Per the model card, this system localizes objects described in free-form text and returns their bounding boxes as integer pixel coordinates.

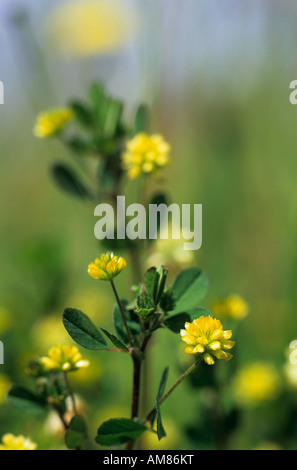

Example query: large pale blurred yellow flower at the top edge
[46,0,139,58]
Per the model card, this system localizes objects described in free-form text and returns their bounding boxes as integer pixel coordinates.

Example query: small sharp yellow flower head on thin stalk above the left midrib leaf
[88,253,127,281]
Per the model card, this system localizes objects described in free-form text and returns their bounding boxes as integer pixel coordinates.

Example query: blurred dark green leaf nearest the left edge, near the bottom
[7,385,47,412]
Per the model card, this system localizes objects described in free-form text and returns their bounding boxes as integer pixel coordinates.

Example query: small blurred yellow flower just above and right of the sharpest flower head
[212,294,249,320]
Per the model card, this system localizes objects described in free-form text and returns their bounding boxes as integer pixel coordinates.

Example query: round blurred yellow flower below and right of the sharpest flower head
[233,362,280,406]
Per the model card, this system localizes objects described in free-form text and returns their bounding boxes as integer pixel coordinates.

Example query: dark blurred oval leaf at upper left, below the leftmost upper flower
[52,164,90,199]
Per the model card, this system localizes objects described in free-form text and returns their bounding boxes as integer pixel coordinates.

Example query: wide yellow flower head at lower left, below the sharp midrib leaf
[40,344,89,372]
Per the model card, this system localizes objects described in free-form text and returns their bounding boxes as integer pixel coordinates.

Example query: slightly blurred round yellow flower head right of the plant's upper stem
[122,132,170,180]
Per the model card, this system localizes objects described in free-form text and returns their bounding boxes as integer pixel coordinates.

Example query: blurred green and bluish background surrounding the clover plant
[0,0,297,449]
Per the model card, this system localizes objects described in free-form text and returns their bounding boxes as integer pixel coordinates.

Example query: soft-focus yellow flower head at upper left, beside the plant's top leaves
[34,108,74,139]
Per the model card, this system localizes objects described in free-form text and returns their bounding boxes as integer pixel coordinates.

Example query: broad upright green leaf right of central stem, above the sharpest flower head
[171,268,208,314]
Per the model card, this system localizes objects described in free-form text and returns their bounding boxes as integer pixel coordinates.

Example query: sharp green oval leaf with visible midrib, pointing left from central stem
[63,308,107,351]
